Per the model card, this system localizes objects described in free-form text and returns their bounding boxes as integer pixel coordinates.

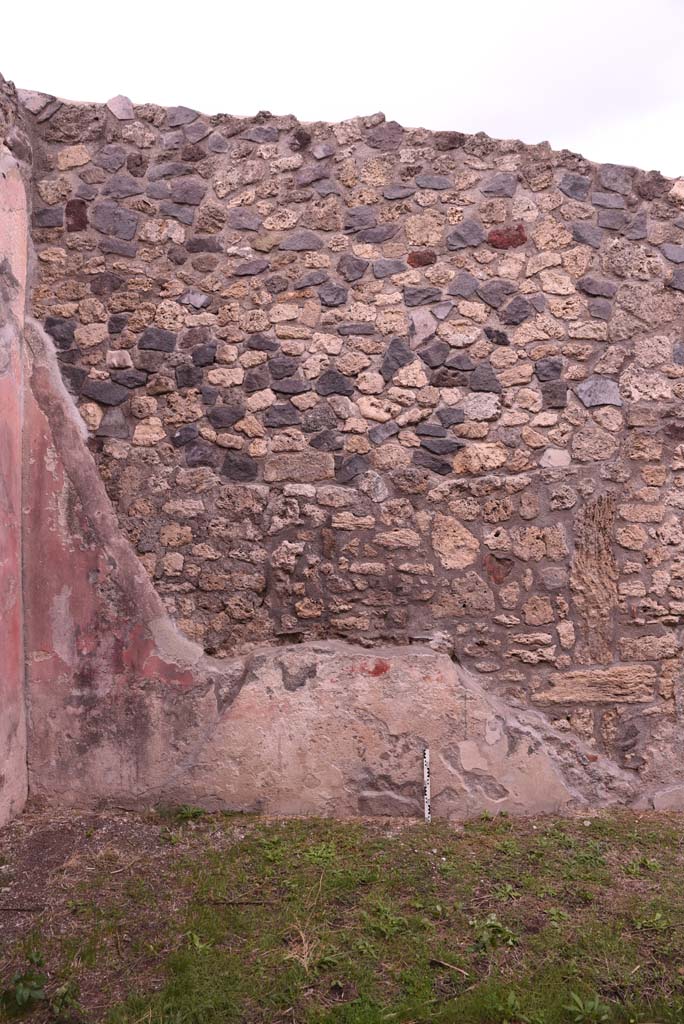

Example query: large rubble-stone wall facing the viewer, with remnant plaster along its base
[3,75,684,815]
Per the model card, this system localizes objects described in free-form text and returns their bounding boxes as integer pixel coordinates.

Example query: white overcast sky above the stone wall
[0,0,684,176]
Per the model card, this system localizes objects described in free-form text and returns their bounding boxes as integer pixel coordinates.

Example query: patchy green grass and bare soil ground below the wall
[0,807,684,1024]
